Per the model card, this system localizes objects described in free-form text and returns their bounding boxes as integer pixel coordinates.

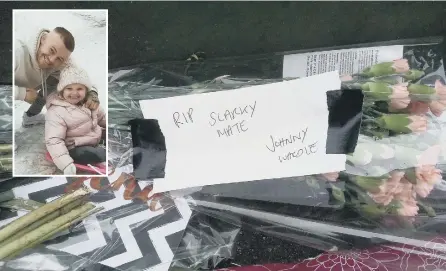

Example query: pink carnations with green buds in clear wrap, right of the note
[324,59,446,225]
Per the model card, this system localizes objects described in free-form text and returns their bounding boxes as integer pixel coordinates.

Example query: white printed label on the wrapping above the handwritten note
[283,45,404,78]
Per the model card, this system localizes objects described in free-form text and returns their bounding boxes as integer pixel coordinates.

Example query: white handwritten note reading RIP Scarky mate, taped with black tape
[140,72,345,192]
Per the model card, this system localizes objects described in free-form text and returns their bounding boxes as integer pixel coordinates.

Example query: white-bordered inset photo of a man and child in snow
[13,10,108,176]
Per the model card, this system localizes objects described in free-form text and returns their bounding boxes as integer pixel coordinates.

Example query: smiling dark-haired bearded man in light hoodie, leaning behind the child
[14,27,99,127]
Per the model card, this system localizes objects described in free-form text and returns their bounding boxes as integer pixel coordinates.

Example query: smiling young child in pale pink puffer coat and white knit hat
[45,65,106,175]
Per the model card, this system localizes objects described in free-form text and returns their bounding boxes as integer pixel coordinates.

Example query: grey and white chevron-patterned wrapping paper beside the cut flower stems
[0,168,191,271]
